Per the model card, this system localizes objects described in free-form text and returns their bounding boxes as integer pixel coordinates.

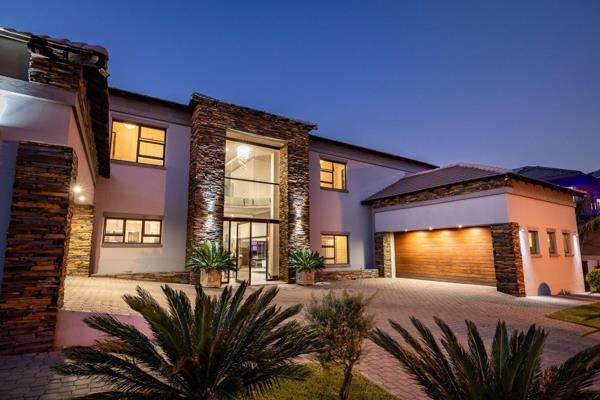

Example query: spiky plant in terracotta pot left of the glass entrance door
[187,240,235,288]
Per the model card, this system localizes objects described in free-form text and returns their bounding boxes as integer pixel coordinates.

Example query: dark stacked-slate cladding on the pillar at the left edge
[0,142,77,355]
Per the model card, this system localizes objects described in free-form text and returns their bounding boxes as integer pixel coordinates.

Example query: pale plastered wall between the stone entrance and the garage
[309,139,432,269]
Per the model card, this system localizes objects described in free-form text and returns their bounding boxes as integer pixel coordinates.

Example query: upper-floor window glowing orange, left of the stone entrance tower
[110,121,166,166]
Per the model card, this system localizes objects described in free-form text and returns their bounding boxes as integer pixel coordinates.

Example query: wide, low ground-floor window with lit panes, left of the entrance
[102,217,162,244]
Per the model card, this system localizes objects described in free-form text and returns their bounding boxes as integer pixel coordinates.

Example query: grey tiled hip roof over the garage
[363,163,579,203]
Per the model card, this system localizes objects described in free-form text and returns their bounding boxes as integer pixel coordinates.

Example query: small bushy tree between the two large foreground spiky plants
[307,291,375,400]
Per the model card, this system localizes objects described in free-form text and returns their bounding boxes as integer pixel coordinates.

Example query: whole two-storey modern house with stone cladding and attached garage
[0,29,583,353]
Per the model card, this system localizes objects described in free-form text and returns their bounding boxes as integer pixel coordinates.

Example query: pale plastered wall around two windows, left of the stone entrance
[95,97,190,274]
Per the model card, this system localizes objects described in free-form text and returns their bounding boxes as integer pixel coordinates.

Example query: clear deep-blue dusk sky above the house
[0,0,600,172]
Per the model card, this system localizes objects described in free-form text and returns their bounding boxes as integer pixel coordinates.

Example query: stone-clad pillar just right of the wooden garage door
[490,222,525,296]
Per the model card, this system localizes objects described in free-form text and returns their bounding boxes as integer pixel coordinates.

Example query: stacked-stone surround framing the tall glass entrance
[187,94,315,281]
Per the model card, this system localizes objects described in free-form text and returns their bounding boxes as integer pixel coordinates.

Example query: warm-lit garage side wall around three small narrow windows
[507,185,584,296]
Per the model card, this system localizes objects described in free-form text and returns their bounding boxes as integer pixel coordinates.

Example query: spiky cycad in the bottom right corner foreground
[371,317,600,400]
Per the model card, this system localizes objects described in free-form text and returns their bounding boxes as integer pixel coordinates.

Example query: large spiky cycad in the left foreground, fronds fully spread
[55,283,320,400]
